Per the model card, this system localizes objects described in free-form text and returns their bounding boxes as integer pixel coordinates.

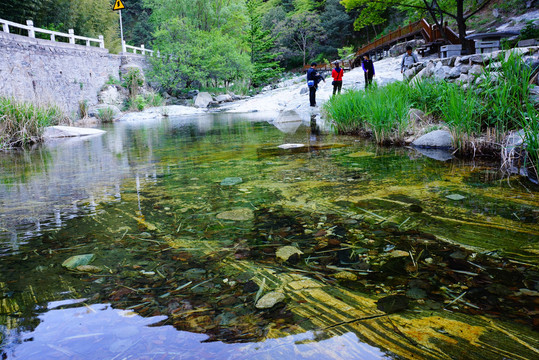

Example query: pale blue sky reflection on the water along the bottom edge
[2,300,384,360]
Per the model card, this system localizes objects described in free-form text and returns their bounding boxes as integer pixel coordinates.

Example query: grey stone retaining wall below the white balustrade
[0,32,152,118]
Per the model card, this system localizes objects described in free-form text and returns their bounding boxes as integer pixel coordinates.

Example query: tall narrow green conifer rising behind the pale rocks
[246,0,282,87]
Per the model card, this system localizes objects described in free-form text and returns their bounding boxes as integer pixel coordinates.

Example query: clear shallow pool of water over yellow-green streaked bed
[0,114,539,359]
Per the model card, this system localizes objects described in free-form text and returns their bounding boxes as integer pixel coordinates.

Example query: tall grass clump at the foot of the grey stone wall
[0,97,68,149]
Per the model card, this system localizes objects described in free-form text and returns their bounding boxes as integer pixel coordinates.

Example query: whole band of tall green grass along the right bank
[324,53,537,160]
